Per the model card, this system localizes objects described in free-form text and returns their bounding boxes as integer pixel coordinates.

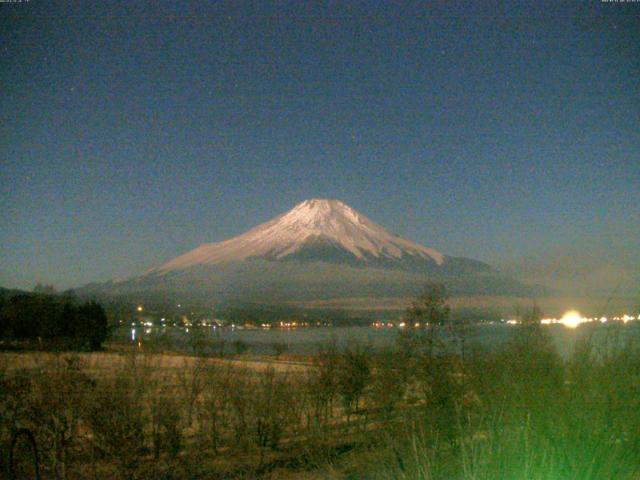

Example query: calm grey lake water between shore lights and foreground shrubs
[114,321,640,355]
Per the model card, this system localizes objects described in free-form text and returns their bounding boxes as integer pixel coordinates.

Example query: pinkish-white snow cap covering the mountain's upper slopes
[154,199,446,274]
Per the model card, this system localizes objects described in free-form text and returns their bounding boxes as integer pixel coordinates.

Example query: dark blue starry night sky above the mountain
[0,0,640,288]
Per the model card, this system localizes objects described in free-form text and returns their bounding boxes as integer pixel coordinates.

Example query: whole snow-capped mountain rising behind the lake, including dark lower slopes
[87,199,527,300]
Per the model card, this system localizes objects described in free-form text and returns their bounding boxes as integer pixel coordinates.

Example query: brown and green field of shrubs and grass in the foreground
[0,286,640,480]
